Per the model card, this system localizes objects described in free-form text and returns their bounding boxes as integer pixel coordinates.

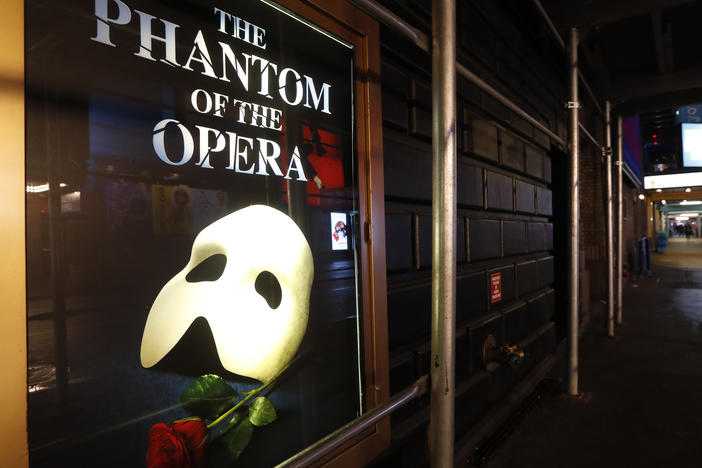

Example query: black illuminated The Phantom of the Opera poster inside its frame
[26,0,363,468]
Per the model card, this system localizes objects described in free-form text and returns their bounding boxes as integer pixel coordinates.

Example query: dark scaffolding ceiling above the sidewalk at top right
[542,0,702,114]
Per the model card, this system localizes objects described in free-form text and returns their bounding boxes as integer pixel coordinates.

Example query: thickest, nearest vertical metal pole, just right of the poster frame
[429,0,456,468]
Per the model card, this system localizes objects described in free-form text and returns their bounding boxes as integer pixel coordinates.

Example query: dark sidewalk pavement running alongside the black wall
[484,239,702,468]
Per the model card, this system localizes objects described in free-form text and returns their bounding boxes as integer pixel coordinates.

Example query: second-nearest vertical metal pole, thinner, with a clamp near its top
[568,28,580,395]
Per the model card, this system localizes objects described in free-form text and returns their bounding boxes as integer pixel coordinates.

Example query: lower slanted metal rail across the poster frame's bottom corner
[276,376,427,468]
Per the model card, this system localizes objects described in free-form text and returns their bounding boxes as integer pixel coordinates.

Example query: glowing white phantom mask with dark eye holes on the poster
[141,205,314,383]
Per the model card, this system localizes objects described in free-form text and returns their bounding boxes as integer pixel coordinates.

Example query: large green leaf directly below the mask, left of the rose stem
[180,374,237,419]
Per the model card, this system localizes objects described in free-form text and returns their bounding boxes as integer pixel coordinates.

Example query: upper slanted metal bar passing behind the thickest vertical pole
[351,0,566,146]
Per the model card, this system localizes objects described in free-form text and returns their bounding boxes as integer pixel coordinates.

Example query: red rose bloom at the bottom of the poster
[146,419,207,468]
